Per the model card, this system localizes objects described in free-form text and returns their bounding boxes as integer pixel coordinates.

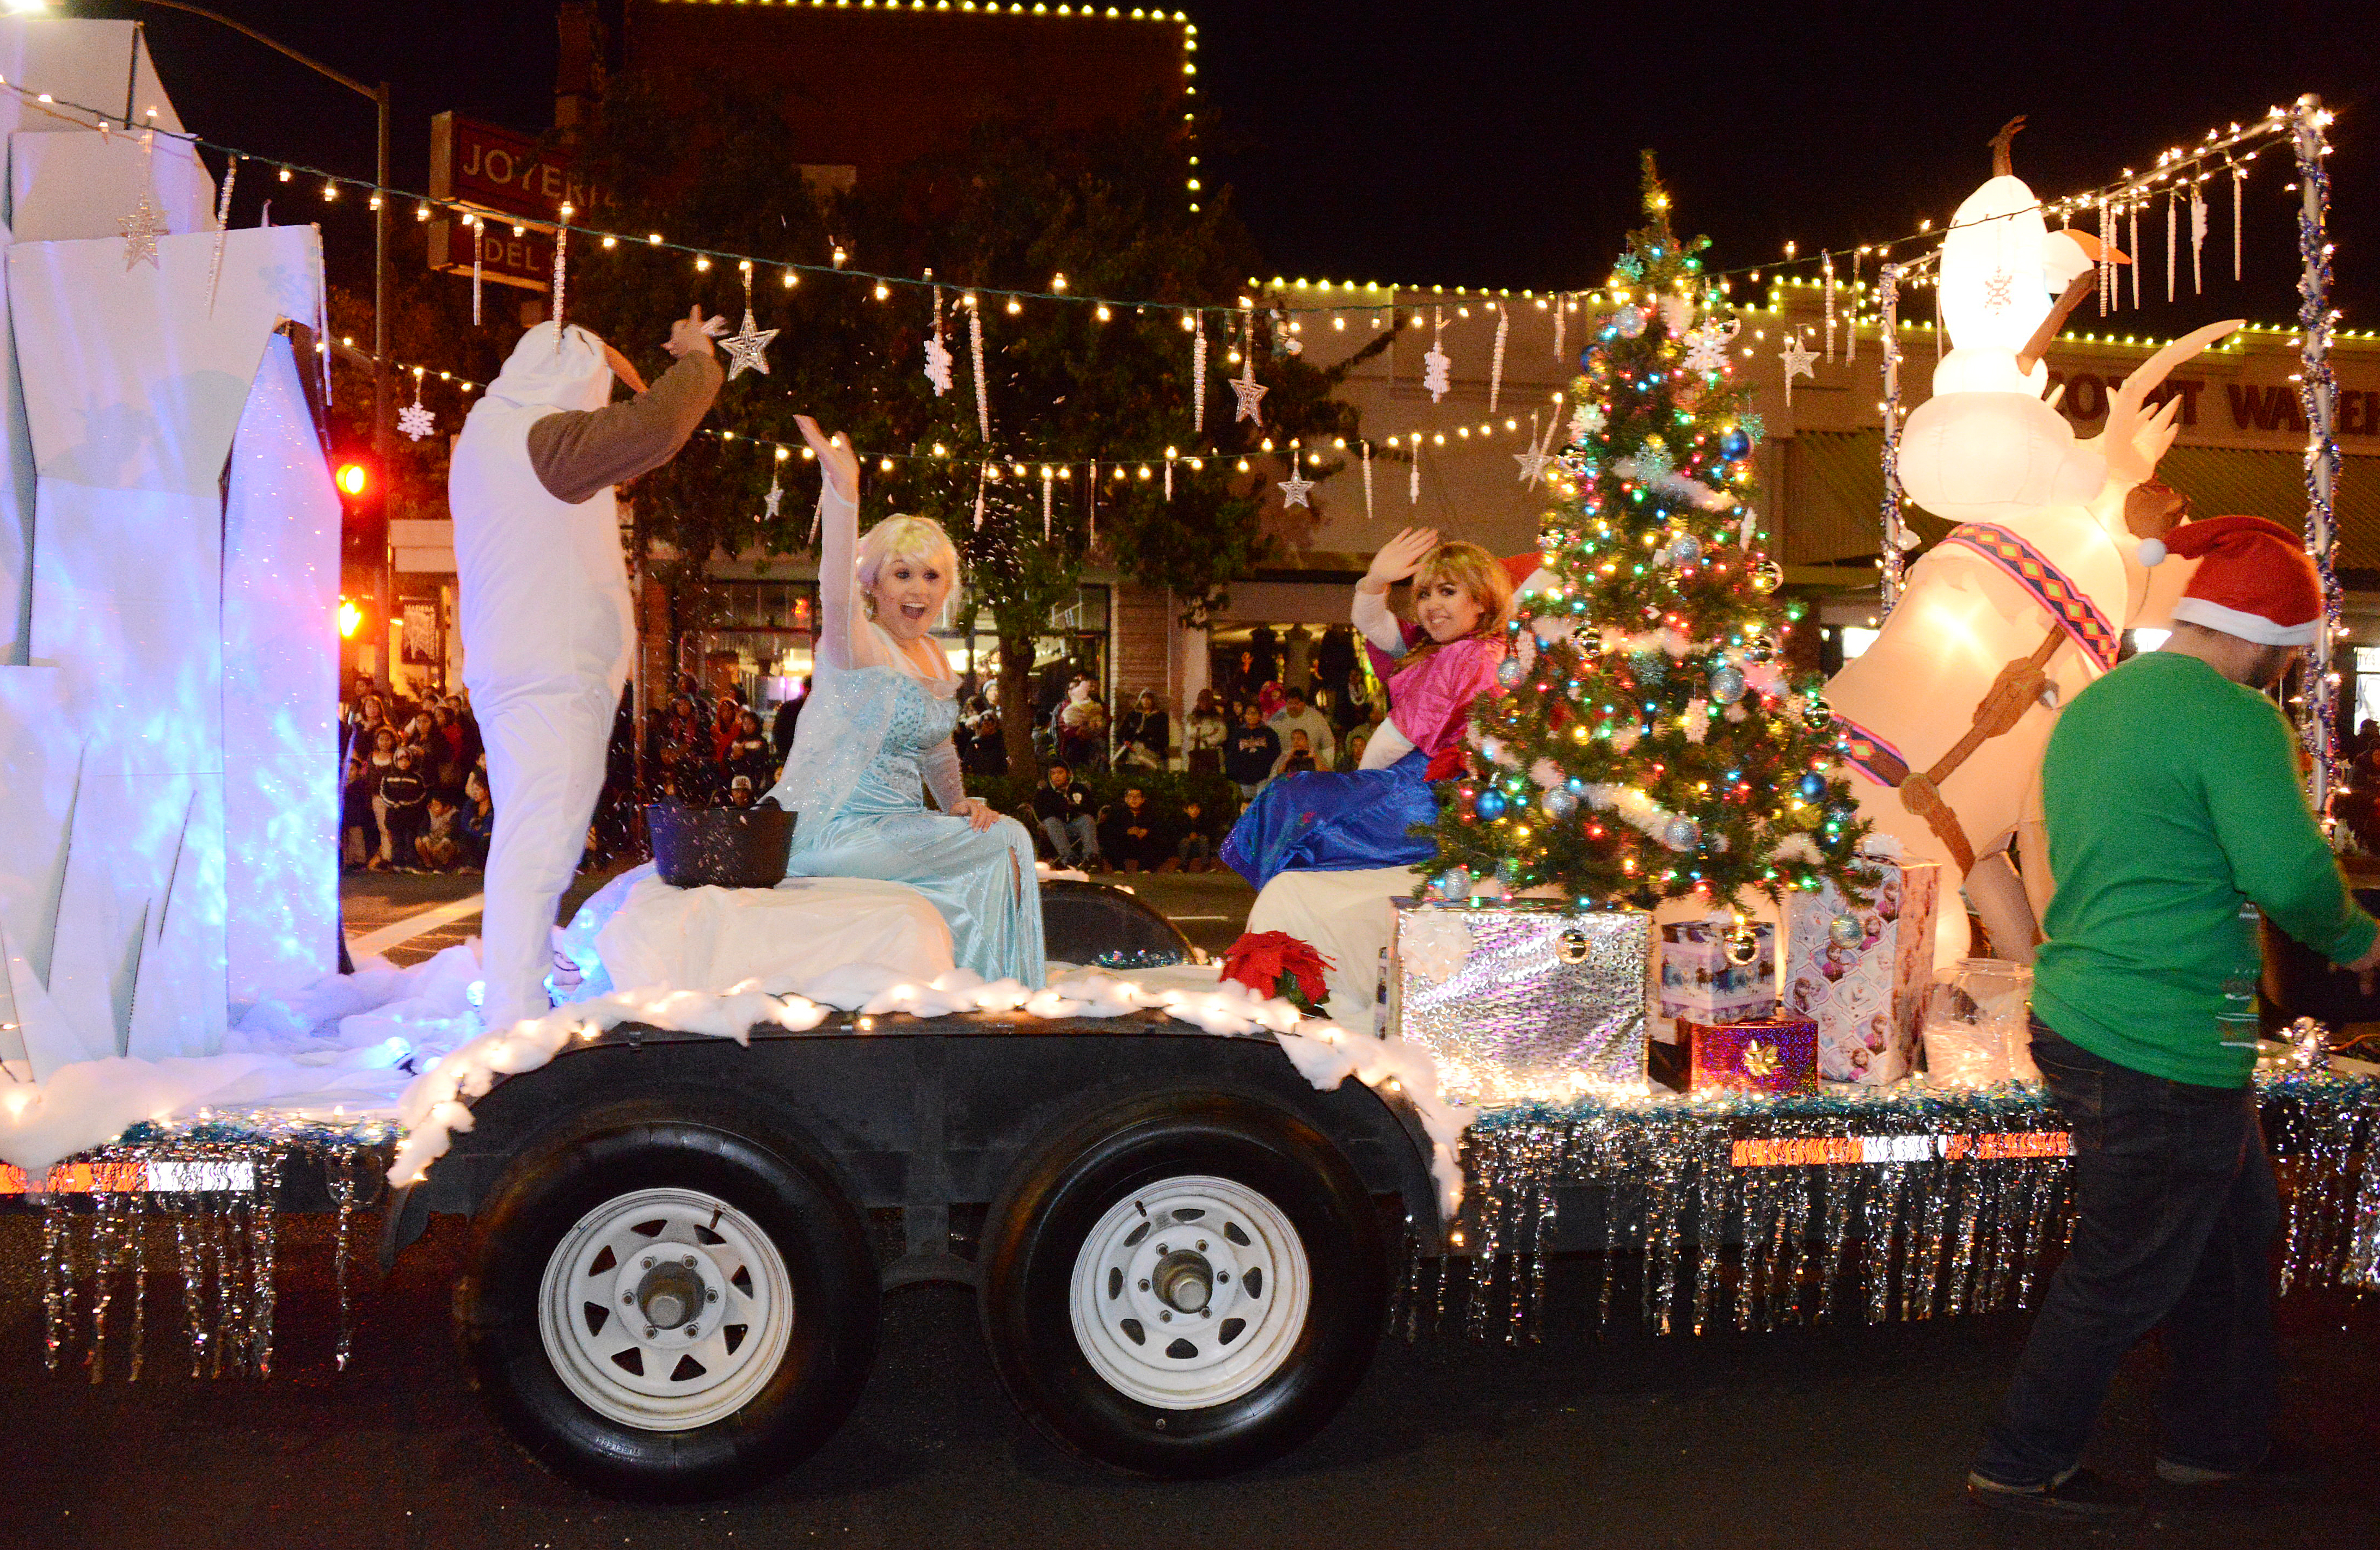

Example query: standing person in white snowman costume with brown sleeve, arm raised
[447,307,721,1029]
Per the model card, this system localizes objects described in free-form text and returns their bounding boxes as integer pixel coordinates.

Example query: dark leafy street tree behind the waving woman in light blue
[571,76,1393,769]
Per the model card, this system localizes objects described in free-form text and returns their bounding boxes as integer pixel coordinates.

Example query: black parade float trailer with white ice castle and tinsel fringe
[0,21,2380,1498]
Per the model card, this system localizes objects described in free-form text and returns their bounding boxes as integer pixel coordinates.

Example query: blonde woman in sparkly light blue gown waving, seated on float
[769,414,1042,988]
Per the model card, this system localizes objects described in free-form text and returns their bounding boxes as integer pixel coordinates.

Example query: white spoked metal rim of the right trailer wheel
[1069,1174,1314,1410]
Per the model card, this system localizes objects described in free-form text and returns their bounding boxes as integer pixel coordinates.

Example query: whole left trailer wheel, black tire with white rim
[455,1100,881,1503]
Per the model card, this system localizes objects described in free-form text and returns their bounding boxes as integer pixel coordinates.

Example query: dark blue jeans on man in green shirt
[1976,1022,2280,1486]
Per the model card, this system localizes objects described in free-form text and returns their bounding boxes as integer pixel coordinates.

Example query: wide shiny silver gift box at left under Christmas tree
[1388,900,1652,1103]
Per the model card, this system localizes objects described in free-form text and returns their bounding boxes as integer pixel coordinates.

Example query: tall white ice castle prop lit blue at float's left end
[0,21,338,1091]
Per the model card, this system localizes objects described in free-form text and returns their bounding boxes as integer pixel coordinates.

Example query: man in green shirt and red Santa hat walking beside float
[1968,516,2380,1519]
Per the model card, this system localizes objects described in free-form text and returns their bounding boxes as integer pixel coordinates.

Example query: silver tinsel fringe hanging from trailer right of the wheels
[1400,1074,2380,1343]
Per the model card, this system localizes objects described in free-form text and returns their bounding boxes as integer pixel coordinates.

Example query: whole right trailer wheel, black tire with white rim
[983,1093,1388,1479]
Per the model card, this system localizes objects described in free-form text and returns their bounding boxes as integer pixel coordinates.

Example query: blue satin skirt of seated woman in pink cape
[1223,748,1438,890]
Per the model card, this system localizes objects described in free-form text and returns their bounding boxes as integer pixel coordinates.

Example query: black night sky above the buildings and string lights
[57,0,2380,333]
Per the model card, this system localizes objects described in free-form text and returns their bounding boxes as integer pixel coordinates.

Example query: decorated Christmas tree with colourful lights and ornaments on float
[1433,152,1866,933]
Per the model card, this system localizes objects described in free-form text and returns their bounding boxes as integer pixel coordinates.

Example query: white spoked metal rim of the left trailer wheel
[538,1188,793,1431]
